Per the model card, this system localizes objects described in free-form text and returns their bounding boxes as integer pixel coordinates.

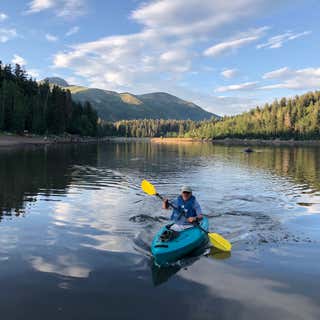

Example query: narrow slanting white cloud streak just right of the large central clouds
[203,27,269,57]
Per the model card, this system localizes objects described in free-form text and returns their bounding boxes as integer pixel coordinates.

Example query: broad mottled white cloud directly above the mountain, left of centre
[54,30,191,90]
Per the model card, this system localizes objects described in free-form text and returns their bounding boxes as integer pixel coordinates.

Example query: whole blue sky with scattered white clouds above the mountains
[0,0,320,115]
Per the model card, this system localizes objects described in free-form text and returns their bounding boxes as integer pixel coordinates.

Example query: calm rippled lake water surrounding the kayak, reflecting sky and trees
[0,142,320,320]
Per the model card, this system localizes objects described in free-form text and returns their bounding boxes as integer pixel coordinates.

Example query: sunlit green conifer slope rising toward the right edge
[187,91,320,140]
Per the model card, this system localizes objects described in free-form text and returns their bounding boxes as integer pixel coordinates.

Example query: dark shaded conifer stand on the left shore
[0,61,98,136]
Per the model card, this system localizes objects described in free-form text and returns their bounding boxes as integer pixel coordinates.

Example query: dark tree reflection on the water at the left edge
[0,145,97,220]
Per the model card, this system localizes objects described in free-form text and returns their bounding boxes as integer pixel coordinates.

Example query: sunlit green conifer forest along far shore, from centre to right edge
[100,91,320,140]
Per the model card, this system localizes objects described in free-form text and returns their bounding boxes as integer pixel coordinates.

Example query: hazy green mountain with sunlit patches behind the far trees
[44,77,218,121]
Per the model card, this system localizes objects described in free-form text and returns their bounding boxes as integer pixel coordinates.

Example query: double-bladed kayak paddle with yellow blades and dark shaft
[141,180,232,252]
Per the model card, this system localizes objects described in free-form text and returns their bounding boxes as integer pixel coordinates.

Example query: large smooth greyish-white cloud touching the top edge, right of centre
[132,0,268,35]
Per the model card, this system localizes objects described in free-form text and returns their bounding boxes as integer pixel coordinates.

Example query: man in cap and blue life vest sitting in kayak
[162,186,202,231]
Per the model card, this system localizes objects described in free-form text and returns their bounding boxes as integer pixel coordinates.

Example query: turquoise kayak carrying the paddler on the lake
[151,217,209,267]
